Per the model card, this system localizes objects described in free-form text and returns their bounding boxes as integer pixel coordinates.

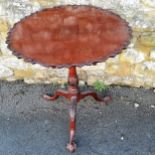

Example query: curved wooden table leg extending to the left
[43,90,69,101]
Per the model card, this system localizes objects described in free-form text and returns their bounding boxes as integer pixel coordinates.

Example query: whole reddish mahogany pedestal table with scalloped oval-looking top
[7,5,131,152]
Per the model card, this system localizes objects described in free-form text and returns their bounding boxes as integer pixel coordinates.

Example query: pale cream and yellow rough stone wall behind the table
[0,0,155,87]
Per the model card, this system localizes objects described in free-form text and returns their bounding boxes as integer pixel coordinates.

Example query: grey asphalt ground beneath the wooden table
[0,81,155,155]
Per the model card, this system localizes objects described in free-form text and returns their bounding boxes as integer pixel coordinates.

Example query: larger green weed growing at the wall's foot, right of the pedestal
[93,80,109,92]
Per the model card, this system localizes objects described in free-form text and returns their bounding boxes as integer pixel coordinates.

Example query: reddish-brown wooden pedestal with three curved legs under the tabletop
[43,67,111,152]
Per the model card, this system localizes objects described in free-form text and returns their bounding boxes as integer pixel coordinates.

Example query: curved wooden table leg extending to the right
[79,91,112,105]
